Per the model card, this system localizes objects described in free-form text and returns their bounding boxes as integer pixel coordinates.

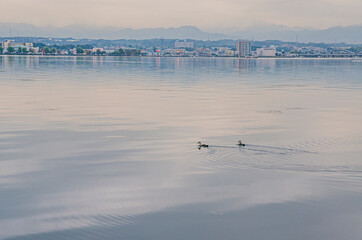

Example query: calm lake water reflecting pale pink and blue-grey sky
[0,56,362,240]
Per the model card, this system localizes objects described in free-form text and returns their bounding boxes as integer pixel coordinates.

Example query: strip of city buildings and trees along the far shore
[0,37,362,58]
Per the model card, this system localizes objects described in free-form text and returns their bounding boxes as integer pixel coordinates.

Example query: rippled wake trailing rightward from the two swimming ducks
[201,136,362,174]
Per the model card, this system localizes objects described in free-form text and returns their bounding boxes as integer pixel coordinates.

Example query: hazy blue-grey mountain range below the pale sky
[0,23,362,44]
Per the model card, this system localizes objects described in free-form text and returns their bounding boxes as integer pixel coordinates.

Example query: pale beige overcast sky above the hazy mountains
[0,0,362,30]
